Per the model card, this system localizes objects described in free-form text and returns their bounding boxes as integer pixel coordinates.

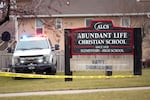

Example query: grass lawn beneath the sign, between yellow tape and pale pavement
[0,69,150,93]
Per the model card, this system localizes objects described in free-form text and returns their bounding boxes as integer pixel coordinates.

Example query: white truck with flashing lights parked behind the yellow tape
[11,37,59,75]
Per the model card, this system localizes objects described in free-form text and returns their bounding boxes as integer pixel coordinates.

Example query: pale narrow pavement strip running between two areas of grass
[0,87,150,97]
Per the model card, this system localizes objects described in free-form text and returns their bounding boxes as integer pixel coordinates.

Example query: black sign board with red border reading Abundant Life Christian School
[71,21,133,55]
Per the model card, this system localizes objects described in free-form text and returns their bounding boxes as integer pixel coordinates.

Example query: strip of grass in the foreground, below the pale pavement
[0,90,150,100]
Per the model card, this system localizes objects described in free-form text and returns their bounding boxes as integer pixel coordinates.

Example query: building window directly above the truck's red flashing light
[36,19,44,35]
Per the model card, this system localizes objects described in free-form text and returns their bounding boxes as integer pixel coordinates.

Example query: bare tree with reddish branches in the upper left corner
[0,0,65,25]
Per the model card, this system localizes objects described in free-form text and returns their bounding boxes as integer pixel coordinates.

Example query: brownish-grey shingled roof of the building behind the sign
[18,0,150,16]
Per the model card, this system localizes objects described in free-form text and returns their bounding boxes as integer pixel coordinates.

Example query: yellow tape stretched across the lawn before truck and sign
[0,72,135,79]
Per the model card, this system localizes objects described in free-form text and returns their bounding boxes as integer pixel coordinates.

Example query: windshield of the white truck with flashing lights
[16,40,49,50]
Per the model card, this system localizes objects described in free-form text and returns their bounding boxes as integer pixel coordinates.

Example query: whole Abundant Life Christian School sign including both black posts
[64,20,142,81]
